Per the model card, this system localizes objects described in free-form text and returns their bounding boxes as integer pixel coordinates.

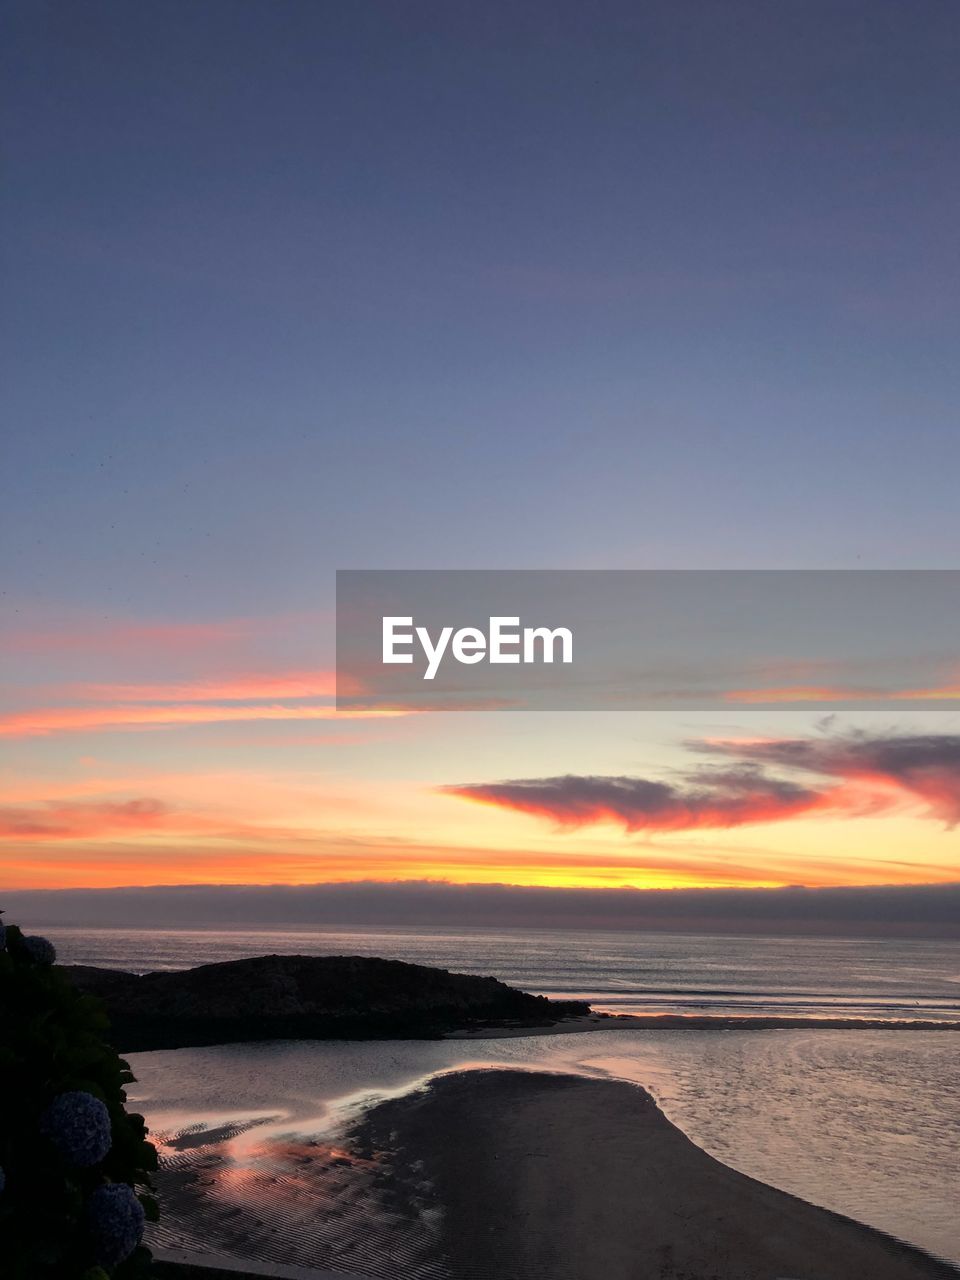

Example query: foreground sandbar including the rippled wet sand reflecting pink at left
[144,1066,960,1280]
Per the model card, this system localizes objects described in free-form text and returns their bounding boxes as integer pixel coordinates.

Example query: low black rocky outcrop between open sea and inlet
[64,956,589,1053]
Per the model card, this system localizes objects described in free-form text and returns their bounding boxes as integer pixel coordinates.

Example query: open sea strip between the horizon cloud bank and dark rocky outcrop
[41,922,960,1023]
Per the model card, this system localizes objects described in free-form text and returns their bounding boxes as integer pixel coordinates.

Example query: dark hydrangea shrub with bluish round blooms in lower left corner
[0,924,156,1280]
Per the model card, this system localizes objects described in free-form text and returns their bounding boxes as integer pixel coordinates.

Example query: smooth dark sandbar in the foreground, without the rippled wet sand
[351,1070,957,1280]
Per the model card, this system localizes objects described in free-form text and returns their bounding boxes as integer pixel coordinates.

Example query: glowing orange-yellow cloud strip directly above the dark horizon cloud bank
[4,812,956,890]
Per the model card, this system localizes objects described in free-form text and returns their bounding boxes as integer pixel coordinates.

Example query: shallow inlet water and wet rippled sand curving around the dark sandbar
[132,1030,960,1280]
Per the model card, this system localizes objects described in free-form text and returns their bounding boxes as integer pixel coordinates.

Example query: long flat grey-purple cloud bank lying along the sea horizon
[0,881,960,946]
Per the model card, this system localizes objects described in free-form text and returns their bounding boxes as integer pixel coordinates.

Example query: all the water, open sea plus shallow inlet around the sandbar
[31,922,960,1280]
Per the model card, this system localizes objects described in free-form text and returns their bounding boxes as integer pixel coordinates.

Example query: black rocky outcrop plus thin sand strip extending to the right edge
[60,955,960,1053]
